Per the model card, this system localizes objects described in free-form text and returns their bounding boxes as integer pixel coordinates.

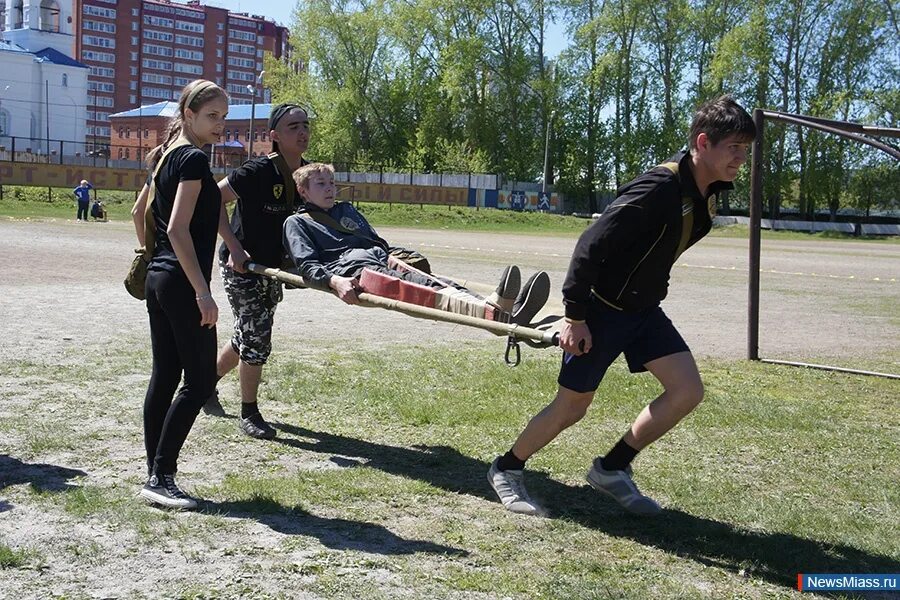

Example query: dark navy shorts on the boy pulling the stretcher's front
[557,301,690,392]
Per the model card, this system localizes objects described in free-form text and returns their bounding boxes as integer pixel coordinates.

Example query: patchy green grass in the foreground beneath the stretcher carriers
[0,342,900,599]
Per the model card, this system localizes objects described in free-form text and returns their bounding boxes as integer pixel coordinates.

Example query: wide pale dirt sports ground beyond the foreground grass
[0,220,900,372]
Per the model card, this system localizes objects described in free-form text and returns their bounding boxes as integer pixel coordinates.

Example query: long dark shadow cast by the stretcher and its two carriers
[272,423,900,589]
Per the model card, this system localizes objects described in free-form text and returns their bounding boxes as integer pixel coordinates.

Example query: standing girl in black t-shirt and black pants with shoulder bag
[132,80,228,508]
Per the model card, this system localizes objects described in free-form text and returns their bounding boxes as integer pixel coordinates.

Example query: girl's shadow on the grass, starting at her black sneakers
[201,498,469,556]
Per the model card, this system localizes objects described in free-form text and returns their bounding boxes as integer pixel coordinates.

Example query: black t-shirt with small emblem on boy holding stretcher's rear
[219,156,307,268]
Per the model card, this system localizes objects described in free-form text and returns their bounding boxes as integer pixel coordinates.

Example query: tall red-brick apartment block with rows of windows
[73,0,290,149]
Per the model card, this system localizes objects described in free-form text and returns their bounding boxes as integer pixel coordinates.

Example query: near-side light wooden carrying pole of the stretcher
[246,262,559,346]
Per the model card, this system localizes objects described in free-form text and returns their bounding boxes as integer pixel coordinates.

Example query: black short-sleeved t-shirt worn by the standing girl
[149,146,222,282]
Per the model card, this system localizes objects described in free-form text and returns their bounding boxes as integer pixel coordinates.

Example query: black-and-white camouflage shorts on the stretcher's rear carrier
[219,262,283,365]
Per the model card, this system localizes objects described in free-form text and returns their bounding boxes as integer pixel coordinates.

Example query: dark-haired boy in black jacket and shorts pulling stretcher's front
[488,96,756,515]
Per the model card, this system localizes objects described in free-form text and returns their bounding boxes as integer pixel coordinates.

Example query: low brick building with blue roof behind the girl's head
[109,101,272,168]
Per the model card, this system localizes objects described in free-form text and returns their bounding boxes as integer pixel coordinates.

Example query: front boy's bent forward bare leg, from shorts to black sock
[624,352,703,450]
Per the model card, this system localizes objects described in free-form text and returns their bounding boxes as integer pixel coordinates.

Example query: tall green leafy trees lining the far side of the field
[266,0,900,214]
